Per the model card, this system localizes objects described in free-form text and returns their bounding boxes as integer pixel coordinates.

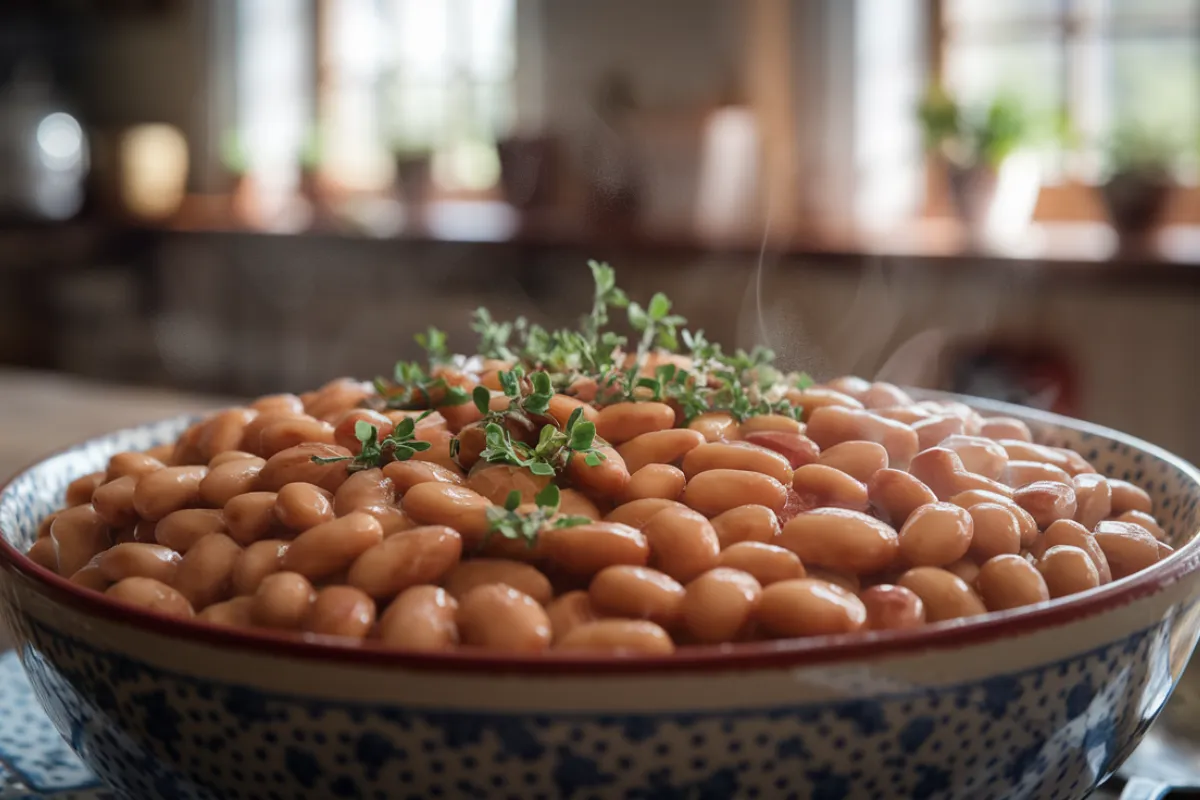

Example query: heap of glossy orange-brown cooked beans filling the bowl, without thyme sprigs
[29,369,1171,655]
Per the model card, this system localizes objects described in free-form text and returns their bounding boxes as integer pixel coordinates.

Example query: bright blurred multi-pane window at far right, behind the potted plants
[935,0,1200,182]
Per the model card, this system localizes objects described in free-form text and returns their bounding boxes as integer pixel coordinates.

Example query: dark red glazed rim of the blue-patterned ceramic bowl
[0,400,1200,675]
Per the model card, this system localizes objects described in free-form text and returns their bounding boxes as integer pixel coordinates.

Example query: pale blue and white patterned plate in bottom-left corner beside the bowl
[0,651,114,800]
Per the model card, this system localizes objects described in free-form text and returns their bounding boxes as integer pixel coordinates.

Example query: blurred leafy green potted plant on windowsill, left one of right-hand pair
[918,88,1039,243]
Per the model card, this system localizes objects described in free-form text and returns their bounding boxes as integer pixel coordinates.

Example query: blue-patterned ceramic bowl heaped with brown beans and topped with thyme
[0,265,1200,798]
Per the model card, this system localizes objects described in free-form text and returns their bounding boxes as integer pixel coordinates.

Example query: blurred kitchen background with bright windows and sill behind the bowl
[0,0,1200,461]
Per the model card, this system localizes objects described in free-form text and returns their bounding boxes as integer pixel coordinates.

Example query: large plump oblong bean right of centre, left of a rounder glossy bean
[779,509,900,575]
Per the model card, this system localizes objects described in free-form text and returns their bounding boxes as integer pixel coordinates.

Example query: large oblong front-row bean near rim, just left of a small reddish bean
[755,578,866,637]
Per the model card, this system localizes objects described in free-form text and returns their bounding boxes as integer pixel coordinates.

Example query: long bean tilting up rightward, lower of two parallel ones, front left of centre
[347,525,462,597]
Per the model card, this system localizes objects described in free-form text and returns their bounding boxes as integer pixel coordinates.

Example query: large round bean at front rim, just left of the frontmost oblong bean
[456,583,551,652]
